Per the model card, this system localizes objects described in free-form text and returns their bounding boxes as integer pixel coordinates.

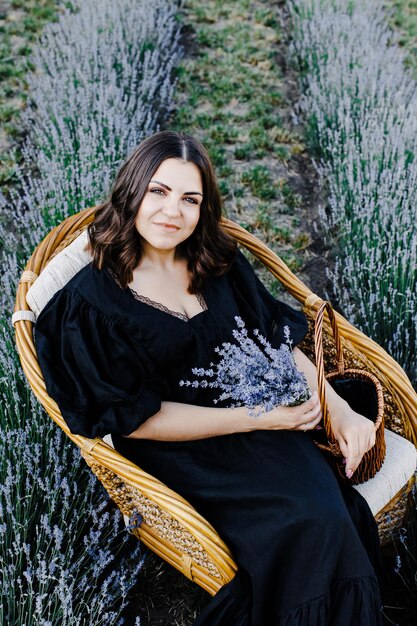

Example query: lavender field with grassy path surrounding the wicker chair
[0,0,417,626]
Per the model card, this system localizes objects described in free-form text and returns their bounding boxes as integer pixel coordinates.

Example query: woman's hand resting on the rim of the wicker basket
[330,402,375,478]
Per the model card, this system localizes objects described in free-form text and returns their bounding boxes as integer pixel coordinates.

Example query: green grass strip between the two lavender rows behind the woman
[165,0,306,294]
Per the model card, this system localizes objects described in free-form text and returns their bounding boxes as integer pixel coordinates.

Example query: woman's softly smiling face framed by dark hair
[135,158,203,253]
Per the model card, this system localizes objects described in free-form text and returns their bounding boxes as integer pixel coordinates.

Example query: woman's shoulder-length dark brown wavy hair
[87,131,237,293]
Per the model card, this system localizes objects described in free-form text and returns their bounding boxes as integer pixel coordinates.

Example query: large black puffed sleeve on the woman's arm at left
[35,288,161,438]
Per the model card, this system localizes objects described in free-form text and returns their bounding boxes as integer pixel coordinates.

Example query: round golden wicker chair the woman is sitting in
[13,207,417,595]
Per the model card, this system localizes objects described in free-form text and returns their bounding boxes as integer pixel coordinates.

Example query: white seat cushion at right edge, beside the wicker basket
[354,429,417,515]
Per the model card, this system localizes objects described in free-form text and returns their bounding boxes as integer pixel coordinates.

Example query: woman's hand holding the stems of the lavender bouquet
[254,391,322,431]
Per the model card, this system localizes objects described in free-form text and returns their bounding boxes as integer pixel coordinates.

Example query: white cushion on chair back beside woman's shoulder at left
[26,229,92,318]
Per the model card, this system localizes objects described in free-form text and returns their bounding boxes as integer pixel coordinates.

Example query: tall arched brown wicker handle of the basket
[314,300,345,456]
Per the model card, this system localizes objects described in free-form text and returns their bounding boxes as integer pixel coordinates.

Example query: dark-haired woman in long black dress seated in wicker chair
[35,131,381,626]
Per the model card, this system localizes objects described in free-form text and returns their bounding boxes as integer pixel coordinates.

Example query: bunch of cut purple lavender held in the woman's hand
[179,316,311,417]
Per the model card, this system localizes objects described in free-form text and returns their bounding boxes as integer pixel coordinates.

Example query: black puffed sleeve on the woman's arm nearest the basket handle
[232,250,308,348]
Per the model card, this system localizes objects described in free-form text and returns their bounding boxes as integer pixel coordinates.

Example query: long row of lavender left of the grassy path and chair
[0,0,181,626]
